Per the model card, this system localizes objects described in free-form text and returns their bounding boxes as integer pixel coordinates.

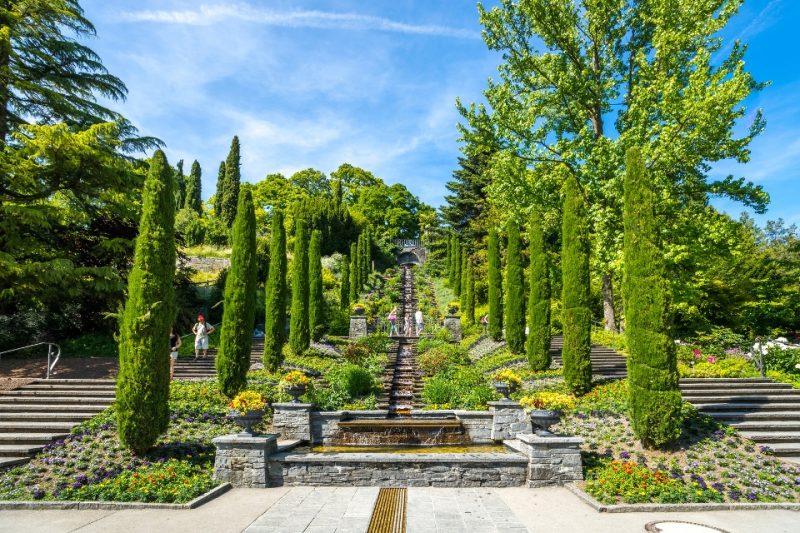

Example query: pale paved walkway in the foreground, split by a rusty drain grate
[0,487,800,533]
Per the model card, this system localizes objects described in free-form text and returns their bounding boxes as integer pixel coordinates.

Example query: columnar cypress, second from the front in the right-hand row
[561,176,592,394]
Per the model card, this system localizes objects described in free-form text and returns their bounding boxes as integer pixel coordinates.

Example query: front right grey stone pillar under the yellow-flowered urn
[517,433,583,487]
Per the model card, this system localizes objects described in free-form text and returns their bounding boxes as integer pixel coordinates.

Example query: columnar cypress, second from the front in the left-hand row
[216,186,257,398]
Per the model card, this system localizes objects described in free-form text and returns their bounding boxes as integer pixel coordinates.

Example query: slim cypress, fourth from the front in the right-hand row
[505,220,525,353]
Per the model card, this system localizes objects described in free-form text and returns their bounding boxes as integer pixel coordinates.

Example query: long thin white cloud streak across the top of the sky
[122,4,480,39]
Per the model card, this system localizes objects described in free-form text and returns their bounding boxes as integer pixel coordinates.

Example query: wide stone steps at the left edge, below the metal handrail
[0,379,116,468]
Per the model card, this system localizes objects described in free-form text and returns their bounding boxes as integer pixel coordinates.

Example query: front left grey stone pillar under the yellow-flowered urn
[213,435,278,488]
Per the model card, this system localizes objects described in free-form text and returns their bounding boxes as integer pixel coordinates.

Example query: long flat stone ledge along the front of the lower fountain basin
[278,452,528,466]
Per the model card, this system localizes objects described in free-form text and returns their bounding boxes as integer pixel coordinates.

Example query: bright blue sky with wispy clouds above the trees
[82,0,800,223]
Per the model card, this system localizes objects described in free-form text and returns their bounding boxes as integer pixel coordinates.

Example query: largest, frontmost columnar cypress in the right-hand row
[623,148,682,447]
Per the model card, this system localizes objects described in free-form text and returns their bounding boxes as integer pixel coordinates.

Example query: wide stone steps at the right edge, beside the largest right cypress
[680,378,800,462]
